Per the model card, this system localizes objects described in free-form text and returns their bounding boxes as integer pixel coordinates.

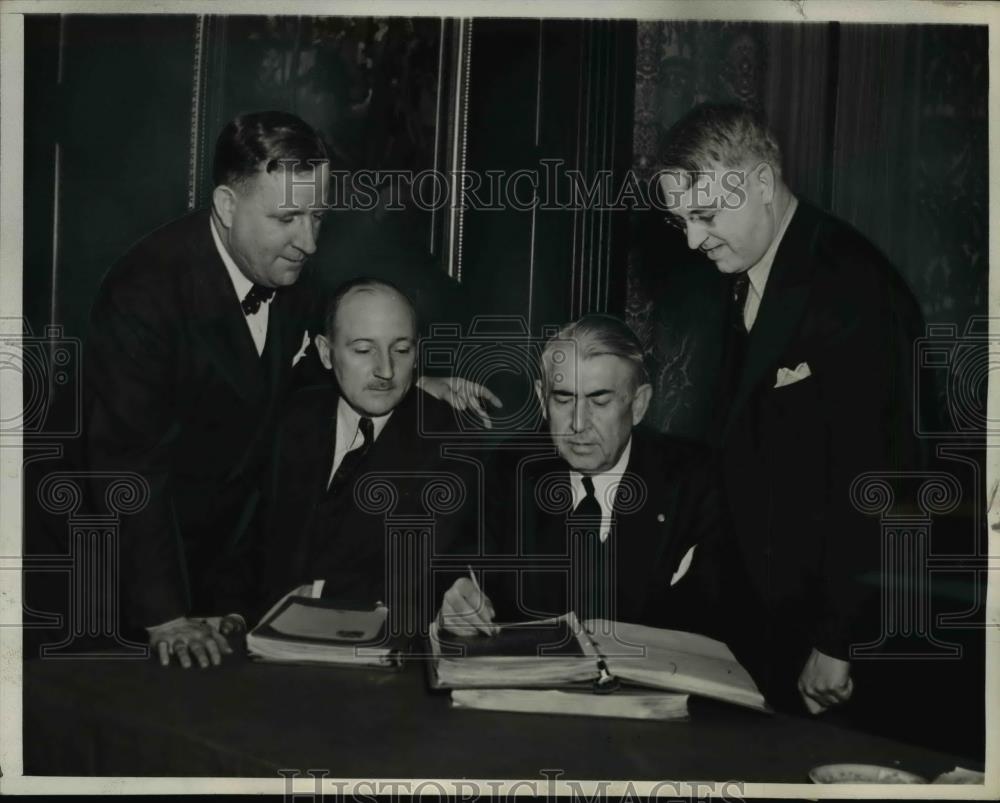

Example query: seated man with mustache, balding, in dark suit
[253,278,474,627]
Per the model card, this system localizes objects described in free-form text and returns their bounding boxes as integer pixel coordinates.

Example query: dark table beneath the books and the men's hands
[24,655,968,783]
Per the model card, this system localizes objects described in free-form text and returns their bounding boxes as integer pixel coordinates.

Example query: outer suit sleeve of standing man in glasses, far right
[811,266,920,660]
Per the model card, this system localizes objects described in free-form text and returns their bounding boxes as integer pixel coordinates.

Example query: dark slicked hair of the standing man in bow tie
[212,111,330,186]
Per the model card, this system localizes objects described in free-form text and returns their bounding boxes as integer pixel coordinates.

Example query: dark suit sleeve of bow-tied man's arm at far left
[84,276,188,627]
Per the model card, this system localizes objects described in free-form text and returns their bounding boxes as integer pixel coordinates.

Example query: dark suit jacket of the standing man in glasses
[720,202,921,693]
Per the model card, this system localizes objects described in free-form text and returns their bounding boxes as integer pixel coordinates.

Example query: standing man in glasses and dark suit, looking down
[659,105,921,713]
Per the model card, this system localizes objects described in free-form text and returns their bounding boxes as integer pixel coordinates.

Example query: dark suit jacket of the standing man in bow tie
[84,211,322,626]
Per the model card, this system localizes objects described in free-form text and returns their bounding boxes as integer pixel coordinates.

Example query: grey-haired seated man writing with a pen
[441,314,715,633]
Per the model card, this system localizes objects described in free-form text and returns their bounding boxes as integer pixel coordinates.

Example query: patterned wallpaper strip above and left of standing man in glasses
[626,22,767,437]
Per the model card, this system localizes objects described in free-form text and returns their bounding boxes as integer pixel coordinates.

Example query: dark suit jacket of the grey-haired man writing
[482,426,718,631]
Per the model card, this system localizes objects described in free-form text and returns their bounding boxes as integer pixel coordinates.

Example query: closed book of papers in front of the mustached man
[247,585,402,667]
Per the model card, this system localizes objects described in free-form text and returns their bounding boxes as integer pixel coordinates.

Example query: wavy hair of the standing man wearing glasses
[660,103,781,173]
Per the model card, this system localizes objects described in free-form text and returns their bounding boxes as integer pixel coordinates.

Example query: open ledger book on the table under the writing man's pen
[430,613,770,719]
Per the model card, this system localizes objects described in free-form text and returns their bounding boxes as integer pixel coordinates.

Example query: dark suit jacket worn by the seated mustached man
[251,383,477,626]
